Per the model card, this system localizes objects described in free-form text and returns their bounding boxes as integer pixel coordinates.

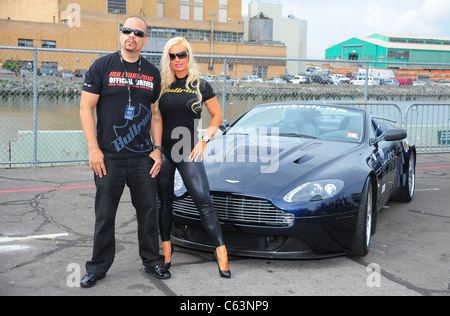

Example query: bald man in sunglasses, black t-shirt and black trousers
[80,16,170,288]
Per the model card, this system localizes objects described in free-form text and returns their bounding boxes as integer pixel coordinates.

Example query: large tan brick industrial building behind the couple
[0,0,286,77]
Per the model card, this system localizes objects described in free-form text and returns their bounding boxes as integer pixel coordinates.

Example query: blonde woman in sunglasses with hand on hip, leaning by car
[158,37,231,278]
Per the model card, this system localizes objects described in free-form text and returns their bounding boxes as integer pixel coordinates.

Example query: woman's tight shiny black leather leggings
[158,155,224,247]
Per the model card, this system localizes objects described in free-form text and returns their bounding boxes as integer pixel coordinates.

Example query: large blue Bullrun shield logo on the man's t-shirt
[112,104,152,153]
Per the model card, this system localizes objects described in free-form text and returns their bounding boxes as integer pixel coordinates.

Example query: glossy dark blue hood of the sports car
[204,135,360,198]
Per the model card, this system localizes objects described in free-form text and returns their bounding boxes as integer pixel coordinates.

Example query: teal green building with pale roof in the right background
[325,34,450,63]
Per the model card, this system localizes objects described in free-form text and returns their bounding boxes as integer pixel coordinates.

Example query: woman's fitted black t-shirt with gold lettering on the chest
[159,76,216,160]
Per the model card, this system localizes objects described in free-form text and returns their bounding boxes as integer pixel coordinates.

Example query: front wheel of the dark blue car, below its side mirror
[349,178,375,257]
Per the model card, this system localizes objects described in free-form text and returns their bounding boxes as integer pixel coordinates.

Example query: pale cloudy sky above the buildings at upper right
[242,0,450,58]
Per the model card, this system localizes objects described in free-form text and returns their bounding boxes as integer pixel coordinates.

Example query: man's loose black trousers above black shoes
[86,157,164,277]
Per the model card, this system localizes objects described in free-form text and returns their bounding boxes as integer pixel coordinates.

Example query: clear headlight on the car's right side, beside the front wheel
[283,179,344,203]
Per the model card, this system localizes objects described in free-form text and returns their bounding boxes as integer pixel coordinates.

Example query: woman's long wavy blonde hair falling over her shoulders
[158,37,202,113]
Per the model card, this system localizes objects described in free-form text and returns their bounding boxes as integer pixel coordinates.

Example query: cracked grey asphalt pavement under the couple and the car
[0,154,450,298]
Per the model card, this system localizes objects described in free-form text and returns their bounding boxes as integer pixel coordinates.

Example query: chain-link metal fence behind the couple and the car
[0,46,450,168]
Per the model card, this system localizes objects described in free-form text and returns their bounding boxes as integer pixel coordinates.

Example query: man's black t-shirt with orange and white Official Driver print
[83,52,161,158]
